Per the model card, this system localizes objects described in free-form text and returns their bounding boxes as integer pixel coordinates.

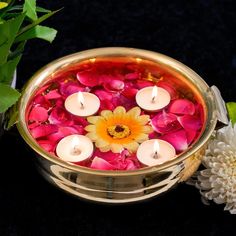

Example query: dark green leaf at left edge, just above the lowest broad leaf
[0,55,21,85]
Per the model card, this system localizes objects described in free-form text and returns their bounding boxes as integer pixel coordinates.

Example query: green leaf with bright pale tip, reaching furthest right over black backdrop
[15,25,57,43]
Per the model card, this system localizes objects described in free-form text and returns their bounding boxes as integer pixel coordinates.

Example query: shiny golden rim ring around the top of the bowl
[17,47,217,177]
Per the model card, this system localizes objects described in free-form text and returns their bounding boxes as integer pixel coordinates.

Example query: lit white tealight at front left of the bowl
[56,134,93,162]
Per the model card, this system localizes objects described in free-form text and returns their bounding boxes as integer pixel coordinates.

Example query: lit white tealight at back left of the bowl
[65,92,100,117]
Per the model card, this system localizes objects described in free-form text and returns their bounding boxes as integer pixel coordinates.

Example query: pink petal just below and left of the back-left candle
[48,107,74,126]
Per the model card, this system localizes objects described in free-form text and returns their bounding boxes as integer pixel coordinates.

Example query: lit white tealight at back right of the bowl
[136,86,170,111]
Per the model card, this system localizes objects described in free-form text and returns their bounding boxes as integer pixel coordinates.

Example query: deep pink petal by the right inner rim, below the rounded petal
[178,115,202,131]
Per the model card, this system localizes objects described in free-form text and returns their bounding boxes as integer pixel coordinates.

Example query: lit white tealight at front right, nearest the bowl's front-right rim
[136,139,176,166]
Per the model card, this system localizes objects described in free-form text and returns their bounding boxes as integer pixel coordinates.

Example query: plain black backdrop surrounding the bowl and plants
[0,0,236,236]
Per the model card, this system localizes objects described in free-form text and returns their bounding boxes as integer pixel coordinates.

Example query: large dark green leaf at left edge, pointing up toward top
[0,13,25,65]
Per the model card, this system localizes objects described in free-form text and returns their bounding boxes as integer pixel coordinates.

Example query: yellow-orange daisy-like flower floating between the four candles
[85,106,152,153]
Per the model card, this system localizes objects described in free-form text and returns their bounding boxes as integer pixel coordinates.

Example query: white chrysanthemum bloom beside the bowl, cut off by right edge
[197,124,236,214]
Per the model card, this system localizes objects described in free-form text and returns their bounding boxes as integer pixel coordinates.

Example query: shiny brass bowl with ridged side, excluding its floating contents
[17,47,227,204]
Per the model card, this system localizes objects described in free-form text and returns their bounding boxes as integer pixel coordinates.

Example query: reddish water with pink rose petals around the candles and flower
[27,58,205,170]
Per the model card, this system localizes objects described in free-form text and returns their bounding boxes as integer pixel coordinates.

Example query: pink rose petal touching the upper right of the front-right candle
[161,129,188,152]
